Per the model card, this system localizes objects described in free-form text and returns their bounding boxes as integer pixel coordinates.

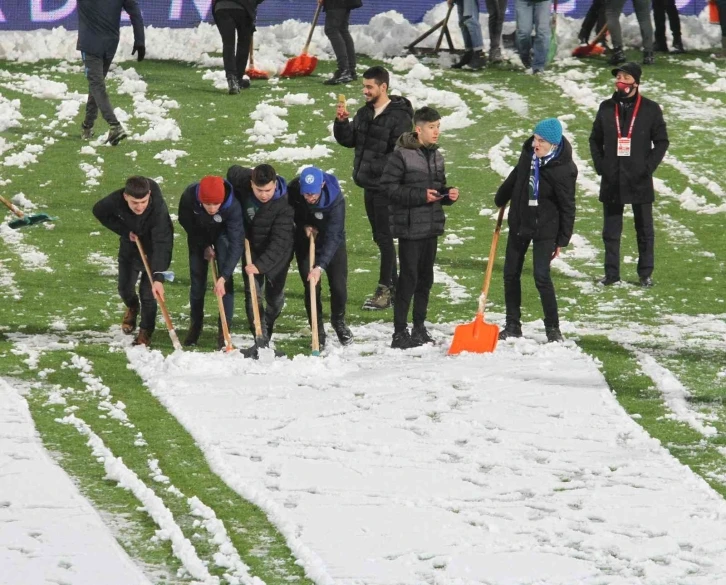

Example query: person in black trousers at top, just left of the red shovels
[212,0,263,95]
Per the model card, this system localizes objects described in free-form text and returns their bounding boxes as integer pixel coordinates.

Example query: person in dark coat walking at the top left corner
[76,0,146,146]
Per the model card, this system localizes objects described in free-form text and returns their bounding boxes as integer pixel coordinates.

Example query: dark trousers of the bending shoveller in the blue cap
[295,237,348,331]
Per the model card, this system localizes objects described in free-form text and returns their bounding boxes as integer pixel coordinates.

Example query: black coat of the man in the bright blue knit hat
[494,136,577,247]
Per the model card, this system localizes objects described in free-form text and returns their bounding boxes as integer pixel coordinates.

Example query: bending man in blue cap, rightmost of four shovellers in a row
[287,167,353,348]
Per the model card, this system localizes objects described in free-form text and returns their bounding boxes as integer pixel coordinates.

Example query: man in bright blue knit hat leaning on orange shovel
[494,118,577,342]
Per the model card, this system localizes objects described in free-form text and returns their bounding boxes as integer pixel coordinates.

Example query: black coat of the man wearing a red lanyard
[590,92,669,204]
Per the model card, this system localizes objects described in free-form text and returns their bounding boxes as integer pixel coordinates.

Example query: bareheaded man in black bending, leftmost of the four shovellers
[93,177,174,346]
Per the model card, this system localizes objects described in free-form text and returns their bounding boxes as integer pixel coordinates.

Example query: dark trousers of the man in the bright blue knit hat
[504,231,560,327]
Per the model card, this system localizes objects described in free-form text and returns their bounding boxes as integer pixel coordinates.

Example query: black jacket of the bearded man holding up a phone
[333,95,413,189]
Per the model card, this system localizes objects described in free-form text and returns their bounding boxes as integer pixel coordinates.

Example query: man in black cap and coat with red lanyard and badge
[590,63,668,287]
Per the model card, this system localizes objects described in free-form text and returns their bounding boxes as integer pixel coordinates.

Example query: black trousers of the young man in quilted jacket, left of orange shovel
[393,236,438,333]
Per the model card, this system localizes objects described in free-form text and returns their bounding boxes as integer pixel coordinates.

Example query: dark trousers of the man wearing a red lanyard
[602,203,655,278]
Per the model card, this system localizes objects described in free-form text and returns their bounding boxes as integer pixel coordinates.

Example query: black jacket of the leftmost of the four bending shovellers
[93,179,174,282]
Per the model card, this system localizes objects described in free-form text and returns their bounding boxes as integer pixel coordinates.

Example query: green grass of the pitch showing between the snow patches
[0,53,726,583]
